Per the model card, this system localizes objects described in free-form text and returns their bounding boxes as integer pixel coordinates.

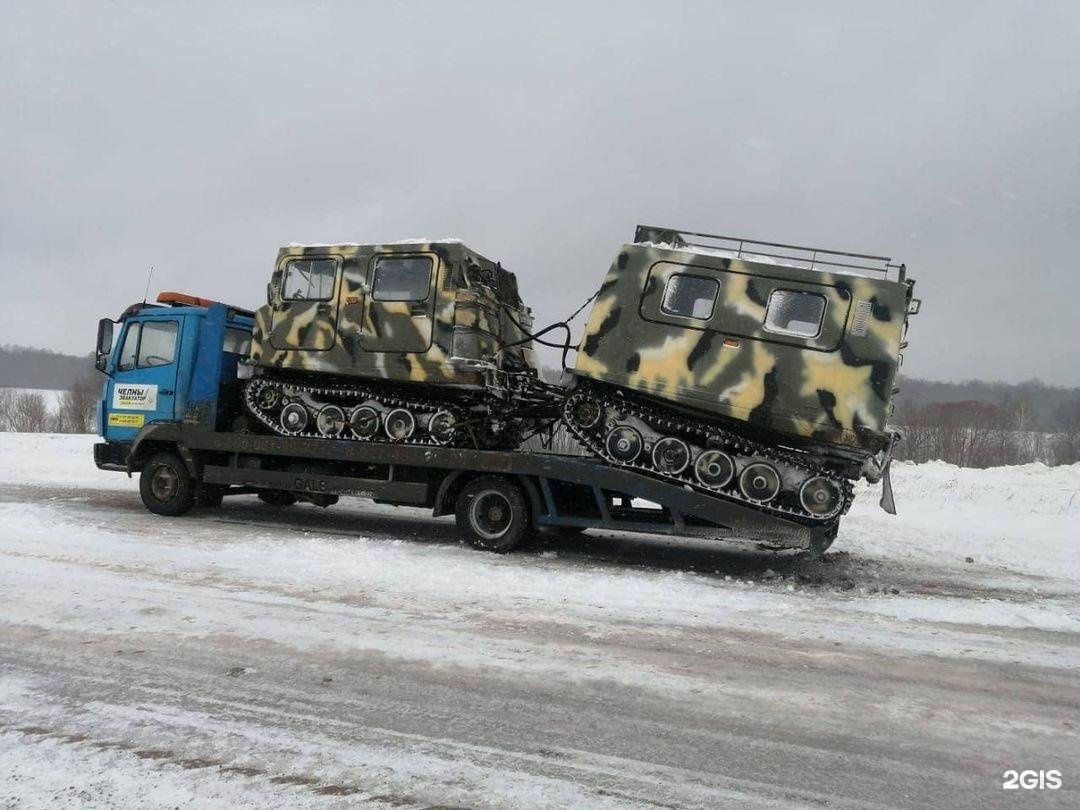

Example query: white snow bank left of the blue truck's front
[0,433,123,489]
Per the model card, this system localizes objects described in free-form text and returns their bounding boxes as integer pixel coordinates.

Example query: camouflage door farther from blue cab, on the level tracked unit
[361,253,438,352]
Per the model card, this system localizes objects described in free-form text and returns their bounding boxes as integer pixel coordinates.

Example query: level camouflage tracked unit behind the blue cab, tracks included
[244,240,546,447]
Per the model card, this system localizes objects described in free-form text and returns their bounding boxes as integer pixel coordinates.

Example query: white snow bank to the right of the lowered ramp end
[837,461,1080,582]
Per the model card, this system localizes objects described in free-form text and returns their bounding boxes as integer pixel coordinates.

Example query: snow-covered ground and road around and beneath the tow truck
[0,434,1080,808]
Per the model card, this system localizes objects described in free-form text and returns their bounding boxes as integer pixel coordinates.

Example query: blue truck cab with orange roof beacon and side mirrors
[95,293,254,469]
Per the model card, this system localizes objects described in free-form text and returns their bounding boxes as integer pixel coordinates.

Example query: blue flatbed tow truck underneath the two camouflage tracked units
[94,293,835,554]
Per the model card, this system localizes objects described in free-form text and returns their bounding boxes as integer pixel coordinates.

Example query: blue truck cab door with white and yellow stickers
[105,319,181,442]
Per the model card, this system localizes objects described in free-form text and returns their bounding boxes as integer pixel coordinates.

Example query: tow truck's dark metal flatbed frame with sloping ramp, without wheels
[120,422,835,549]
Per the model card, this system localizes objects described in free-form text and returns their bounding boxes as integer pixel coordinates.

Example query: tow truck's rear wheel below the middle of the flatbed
[455,475,532,554]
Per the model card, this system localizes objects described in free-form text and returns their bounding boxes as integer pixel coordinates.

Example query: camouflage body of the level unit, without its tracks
[251,241,534,389]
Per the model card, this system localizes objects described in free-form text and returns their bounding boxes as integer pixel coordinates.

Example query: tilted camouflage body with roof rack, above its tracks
[575,226,918,462]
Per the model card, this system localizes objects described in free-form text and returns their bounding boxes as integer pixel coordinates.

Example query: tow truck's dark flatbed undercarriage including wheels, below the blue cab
[95,422,835,553]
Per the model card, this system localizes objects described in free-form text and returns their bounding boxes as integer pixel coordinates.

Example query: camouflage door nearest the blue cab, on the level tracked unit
[270,256,341,351]
